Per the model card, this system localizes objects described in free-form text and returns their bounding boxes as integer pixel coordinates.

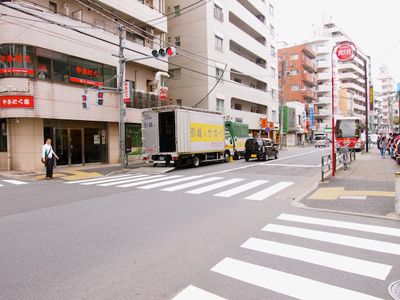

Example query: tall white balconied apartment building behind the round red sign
[310,12,371,127]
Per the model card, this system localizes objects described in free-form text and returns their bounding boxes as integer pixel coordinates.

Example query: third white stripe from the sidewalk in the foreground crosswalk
[241,238,392,280]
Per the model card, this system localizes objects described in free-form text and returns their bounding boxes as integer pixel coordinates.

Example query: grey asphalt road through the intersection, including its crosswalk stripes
[0,148,400,299]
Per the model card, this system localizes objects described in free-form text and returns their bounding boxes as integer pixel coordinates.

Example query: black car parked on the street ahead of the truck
[244,138,279,161]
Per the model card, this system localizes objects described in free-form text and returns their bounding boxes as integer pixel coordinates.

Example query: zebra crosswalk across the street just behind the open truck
[64,174,294,201]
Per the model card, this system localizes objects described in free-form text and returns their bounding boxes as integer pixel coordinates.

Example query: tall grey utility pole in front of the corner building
[118,25,125,168]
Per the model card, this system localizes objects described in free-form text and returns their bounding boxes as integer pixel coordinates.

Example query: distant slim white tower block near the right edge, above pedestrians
[378,65,399,133]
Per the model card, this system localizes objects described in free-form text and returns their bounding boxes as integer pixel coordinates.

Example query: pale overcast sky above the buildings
[275,0,400,86]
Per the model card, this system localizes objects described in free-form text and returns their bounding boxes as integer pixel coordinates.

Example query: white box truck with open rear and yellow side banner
[142,106,230,167]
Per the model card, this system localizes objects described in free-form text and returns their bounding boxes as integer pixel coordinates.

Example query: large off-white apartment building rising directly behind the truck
[166,0,279,137]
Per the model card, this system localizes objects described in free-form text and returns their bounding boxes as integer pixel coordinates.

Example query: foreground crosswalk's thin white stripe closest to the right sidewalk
[277,214,400,237]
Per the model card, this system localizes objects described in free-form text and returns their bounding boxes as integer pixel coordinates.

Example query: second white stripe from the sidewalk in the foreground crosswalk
[262,224,400,255]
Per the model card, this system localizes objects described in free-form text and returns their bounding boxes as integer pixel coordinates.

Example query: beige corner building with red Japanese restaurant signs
[0,0,168,170]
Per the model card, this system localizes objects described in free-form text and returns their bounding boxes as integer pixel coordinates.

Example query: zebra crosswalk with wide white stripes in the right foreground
[173,214,400,300]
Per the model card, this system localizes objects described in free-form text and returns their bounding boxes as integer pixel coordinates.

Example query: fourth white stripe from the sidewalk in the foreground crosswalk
[211,257,379,300]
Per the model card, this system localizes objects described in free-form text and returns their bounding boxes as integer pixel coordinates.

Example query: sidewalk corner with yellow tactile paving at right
[293,147,400,220]
